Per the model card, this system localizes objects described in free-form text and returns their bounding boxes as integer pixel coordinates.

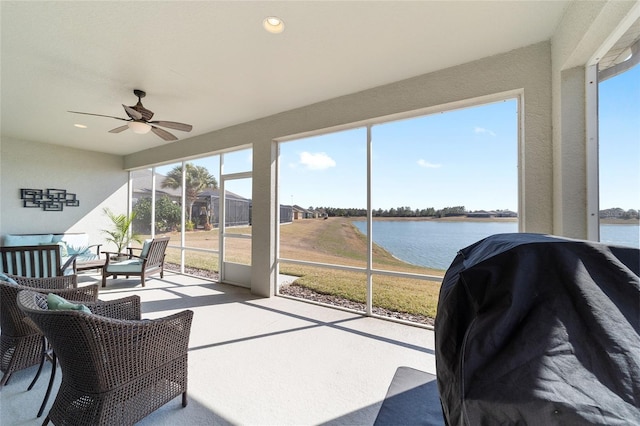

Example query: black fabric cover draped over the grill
[435,234,640,426]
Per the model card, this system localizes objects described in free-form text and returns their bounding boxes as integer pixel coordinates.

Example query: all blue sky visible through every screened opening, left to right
[158,66,640,211]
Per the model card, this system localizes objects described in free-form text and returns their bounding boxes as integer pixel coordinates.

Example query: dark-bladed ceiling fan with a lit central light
[68,89,193,141]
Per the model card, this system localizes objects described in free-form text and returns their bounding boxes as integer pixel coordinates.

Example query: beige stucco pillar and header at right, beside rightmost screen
[551,0,640,239]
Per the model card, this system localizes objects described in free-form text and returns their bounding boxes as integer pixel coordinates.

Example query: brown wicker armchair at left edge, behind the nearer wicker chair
[0,274,98,389]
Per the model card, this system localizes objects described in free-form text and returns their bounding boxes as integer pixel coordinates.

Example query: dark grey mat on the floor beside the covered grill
[374,367,444,426]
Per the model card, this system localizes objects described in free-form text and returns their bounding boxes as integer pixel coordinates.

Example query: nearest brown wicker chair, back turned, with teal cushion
[18,291,193,425]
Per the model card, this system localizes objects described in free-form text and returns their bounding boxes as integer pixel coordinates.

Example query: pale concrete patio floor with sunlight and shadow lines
[0,272,435,425]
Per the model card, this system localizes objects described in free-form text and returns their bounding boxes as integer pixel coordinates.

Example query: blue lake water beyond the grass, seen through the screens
[353,220,640,269]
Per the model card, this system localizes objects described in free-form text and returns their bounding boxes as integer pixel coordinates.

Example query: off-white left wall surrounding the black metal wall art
[0,138,128,248]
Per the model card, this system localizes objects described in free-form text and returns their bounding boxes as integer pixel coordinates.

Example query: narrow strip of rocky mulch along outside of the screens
[164,263,434,326]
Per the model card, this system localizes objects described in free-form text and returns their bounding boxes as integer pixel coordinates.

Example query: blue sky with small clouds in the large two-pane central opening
[280,100,517,210]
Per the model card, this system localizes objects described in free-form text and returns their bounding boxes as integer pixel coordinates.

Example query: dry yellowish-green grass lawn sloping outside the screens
[149,218,444,318]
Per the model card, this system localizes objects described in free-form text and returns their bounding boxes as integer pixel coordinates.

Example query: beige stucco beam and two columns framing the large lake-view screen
[125,42,553,295]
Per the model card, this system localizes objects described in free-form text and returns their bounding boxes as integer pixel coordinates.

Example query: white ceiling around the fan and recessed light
[0,0,569,155]
